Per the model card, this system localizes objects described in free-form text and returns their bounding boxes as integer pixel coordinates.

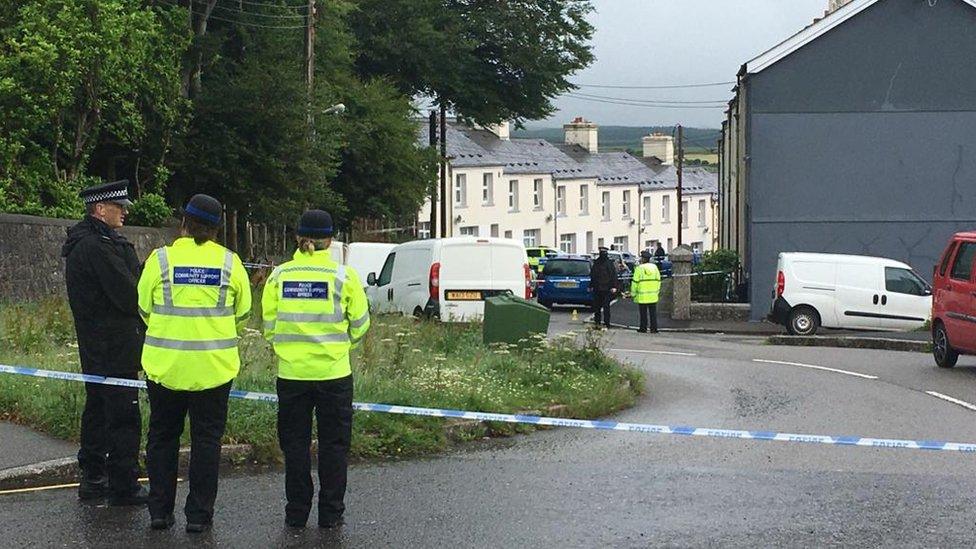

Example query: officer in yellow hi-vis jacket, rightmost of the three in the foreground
[261,210,369,528]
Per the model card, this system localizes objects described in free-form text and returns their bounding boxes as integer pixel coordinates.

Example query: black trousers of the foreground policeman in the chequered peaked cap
[78,372,142,494]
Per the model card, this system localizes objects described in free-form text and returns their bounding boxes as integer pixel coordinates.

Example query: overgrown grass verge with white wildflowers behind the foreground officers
[0,300,644,461]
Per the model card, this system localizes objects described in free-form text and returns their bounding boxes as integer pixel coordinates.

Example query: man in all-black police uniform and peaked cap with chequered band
[61,180,147,505]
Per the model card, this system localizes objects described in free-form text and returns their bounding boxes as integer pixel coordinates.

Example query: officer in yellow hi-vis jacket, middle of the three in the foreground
[139,194,251,532]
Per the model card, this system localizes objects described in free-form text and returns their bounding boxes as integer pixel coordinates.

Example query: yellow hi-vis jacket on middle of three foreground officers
[139,237,251,391]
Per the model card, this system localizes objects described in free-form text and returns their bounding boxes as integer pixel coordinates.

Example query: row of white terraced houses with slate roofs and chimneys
[417,118,717,254]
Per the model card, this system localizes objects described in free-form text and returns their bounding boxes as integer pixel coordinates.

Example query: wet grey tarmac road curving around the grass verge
[0,317,976,547]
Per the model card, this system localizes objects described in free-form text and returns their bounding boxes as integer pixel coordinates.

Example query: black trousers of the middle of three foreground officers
[146,380,230,524]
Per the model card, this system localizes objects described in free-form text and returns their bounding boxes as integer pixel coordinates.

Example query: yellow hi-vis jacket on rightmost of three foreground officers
[261,250,369,381]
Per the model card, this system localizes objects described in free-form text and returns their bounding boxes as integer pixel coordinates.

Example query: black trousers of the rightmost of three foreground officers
[278,375,352,524]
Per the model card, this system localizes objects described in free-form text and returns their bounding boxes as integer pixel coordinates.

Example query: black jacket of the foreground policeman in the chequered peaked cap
[61,217,145,375]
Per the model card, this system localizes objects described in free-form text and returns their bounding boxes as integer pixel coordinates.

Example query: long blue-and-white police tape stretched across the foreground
[0,364,976,453]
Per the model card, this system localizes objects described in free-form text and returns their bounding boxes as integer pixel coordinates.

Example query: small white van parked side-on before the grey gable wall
[768,253,932,335]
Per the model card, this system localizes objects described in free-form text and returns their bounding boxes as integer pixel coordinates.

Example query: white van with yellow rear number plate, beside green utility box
[366,236,532,321]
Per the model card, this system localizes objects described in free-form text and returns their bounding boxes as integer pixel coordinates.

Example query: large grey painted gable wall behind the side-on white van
[747,0,976,318]
